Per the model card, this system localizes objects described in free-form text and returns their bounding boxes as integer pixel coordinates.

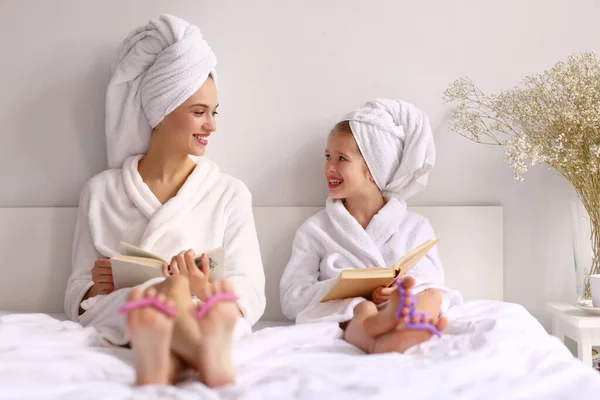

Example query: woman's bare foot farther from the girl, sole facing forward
[127,288,173,385]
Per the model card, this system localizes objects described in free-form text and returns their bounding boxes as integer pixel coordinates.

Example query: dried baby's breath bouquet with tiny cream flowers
[443,52,600,294]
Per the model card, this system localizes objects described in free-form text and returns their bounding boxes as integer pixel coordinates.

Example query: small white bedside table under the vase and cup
[548,303,600,367]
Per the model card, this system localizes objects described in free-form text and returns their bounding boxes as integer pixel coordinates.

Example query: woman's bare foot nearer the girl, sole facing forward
[195,280,240,387]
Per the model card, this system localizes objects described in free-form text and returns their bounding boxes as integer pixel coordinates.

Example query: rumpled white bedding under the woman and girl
[0,301,600,400]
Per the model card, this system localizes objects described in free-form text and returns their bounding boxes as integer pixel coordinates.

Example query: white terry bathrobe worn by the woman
[65,155,266,345]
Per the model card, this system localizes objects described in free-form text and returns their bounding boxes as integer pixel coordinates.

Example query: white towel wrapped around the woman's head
[106,14,217,168]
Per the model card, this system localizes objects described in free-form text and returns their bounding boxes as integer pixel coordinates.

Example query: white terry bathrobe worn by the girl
[280,197,462,322]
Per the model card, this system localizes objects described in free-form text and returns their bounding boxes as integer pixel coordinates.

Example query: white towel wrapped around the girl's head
[342,99,435,201]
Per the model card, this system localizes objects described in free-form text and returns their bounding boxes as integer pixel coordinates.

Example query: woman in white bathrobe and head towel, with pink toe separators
[65,15,265,386]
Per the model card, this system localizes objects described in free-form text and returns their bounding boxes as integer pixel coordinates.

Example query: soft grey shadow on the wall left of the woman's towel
[6,48,114,206]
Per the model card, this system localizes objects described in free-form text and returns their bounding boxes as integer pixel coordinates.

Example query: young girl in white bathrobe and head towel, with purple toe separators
[280,99,462,353]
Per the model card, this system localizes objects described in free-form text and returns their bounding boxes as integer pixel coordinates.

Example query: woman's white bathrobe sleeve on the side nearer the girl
[224,183,266,325]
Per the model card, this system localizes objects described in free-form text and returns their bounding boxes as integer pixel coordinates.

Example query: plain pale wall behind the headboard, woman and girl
[0,0,600,326]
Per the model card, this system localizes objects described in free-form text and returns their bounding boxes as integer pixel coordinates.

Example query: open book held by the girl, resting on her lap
[321,239,439,303]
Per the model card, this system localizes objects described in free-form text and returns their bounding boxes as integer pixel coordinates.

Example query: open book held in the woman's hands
[110,242,225,290]
